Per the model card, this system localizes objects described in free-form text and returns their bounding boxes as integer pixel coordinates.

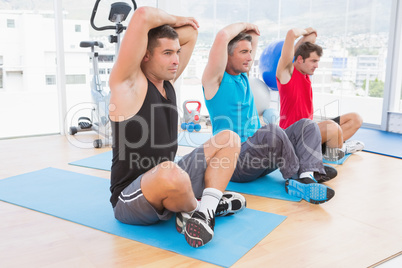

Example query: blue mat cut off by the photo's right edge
[350,128,402,158]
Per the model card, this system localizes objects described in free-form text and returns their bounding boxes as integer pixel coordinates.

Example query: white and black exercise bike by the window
[69,0,137,148]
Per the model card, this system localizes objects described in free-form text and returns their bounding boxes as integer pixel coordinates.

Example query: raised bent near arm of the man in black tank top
[109,7,198,121]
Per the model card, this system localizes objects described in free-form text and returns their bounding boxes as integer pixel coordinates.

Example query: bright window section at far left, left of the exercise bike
[0,0,59,139]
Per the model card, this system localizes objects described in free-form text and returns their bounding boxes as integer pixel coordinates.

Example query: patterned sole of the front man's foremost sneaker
[184,218,214,248]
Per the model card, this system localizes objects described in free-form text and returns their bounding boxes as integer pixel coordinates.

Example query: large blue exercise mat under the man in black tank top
[0,168,286,267]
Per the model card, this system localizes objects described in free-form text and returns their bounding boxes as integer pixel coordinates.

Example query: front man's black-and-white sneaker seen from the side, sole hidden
[215,192,246,217]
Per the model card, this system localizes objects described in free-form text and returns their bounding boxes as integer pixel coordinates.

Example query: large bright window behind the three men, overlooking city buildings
[170,0,393,125]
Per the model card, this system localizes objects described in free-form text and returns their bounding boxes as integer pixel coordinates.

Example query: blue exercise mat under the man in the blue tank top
[70,151,301,201]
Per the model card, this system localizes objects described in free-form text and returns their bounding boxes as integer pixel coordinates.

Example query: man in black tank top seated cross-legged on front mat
[109,7,245,247]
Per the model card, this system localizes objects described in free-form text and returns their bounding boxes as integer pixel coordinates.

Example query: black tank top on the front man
[110,80,178,207]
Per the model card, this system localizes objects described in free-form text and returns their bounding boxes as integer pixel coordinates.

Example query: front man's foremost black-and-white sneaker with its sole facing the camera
[184,211,215,248]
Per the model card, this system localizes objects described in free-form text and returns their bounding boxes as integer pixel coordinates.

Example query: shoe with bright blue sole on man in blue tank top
[285,177,335,204]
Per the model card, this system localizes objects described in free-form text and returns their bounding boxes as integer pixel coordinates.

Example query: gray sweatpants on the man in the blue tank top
[231,119,325,182]
